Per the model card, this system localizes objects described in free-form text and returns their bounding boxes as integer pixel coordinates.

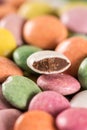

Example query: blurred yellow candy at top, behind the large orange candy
[18,2,56,19]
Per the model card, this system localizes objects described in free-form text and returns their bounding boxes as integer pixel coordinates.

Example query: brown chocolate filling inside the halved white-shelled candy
[33,57,69,72]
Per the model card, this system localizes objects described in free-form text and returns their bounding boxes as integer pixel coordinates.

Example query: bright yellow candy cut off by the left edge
[0,28,17,56]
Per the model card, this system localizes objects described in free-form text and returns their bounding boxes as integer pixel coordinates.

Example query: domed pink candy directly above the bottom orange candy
[29,91,70,116]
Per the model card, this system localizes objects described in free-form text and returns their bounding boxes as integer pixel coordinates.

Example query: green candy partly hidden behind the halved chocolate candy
[13,45,41,72]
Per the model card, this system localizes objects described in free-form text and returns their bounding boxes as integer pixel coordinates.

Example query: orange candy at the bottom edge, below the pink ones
[14,111,58,130]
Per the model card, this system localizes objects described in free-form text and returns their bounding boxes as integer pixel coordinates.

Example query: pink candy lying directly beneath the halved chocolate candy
[37,73,81,95]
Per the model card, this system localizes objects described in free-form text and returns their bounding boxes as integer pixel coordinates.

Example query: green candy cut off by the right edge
[78,58,87,89]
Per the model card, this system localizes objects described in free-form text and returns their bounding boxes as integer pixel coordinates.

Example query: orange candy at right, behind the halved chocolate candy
[55,37,87,76]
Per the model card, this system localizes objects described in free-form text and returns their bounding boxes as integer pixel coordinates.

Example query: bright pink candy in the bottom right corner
[56,108,87,130]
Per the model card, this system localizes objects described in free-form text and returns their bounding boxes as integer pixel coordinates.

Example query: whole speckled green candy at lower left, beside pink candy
[2,76,41,110]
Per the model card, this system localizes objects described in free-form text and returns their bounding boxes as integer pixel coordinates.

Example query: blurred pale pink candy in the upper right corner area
[61,7,87,34]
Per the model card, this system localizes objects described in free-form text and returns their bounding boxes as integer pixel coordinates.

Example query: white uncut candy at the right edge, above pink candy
[70,90,87,108]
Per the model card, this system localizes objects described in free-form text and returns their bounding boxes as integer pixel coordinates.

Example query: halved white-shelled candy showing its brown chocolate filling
[27,50,71,74]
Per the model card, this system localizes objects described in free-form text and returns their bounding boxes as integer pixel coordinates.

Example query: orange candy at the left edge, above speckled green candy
[0,56,23,83]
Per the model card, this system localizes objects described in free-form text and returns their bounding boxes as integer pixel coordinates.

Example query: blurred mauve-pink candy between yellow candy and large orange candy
[0,13,25,46]
